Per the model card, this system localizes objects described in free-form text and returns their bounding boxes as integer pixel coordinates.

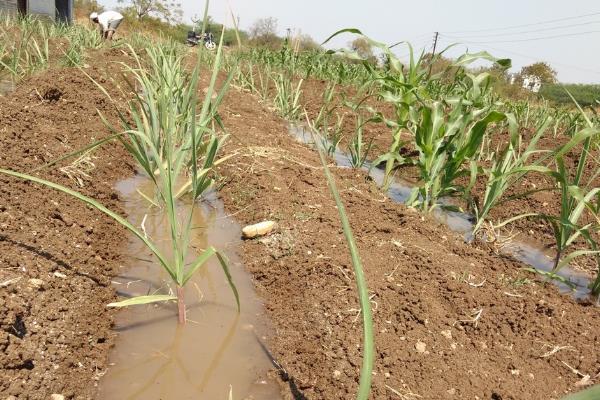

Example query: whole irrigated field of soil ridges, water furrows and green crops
[0,10,600,400]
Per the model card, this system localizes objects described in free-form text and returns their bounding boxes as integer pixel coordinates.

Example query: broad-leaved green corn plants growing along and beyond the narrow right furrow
[226,29,600,296]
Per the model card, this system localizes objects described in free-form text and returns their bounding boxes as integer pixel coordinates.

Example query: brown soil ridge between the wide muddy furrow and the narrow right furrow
[213,83,600,399]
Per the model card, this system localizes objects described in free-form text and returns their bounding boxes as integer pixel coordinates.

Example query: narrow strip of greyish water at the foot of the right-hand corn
[289,123,590,299]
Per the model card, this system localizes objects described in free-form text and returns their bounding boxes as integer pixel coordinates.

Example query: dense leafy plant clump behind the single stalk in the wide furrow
[91,43,231,200]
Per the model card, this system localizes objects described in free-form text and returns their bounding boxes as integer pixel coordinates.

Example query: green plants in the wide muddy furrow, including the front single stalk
[0,33,239,323]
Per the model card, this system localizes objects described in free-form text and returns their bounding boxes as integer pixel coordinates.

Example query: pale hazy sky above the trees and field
[99,0,600,83]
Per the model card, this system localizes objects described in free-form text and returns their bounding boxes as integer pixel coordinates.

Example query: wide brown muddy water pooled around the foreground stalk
[98,176,280,400]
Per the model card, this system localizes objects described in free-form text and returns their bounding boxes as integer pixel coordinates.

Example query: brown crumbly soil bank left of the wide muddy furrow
[0,51,132,399]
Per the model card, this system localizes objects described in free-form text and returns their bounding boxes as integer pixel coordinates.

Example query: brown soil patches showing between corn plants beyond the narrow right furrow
[302,79,600,276]
